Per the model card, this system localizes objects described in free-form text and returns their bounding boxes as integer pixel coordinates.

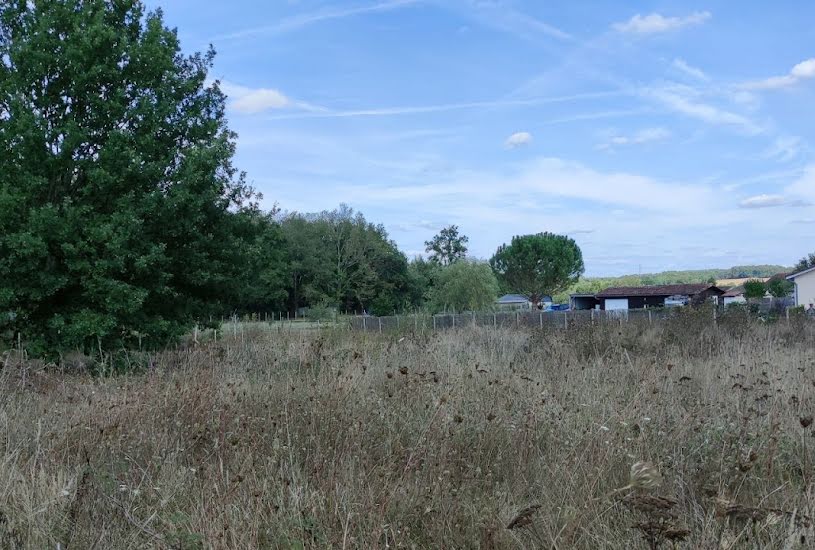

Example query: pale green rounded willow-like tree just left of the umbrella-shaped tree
[430,260,498,312]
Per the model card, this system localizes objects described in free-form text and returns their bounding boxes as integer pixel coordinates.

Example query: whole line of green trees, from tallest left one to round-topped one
[0,0,583,356]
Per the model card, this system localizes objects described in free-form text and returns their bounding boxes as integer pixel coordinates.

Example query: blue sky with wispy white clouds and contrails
[147,0,815,276]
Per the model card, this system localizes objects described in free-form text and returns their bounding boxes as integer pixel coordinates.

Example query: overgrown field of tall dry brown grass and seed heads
[0,314,815,549]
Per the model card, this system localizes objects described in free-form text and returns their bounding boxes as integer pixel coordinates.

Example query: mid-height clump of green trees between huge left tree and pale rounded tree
[281,205,420,315]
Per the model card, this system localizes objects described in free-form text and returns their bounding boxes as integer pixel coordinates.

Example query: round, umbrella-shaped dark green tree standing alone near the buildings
[490,232,585,305]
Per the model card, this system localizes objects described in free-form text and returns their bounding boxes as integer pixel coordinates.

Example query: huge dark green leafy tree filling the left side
[0,0,257,358]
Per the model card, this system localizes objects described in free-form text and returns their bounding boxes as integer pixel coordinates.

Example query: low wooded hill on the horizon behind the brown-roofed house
[555,265,792,302]
